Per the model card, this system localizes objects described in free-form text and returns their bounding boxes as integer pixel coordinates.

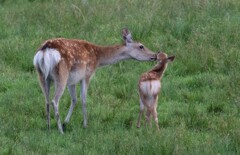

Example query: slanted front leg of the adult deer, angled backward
[63,85,77,127]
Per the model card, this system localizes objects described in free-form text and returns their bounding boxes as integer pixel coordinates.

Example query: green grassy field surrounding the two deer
[0,0,240,155]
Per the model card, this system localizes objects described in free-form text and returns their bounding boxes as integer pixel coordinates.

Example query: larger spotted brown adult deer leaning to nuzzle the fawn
[33,28,156,133]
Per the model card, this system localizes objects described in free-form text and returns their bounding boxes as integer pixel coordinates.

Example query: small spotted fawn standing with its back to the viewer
[137,52,175,130]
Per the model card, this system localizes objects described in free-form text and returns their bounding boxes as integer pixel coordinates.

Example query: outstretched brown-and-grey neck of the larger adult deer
[96,45,131,66]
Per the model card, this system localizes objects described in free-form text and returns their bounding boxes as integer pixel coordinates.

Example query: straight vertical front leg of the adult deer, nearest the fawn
[81,77,90,128]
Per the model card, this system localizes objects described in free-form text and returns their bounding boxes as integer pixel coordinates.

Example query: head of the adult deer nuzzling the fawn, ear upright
[122,28,156,61]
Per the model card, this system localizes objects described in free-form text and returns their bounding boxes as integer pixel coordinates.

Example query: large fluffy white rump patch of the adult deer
[33,48,61,78]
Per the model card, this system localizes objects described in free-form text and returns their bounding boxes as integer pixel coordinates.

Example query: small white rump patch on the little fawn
[140,80,161,97]
